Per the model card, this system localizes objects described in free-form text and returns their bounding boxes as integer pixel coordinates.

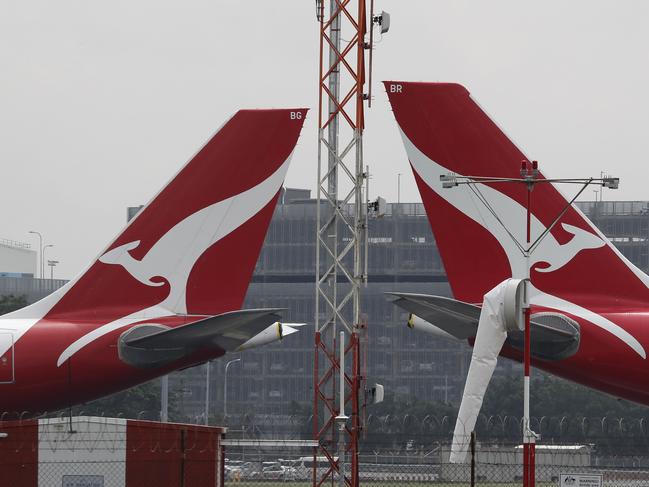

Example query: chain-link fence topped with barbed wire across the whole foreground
[6,415,649,487]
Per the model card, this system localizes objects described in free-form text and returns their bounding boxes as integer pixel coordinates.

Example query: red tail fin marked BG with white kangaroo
[25,109,306,323]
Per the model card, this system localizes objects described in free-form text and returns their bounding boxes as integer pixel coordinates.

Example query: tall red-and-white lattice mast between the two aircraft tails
[313,0,372,487]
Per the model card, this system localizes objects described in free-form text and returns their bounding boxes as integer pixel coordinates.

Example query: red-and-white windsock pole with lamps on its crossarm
[440,165,620,487]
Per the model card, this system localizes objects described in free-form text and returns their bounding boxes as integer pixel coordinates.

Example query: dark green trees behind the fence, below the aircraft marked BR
[280,370,649,452]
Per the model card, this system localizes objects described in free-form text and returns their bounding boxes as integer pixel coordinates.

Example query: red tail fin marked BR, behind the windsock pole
[385,81,649,309]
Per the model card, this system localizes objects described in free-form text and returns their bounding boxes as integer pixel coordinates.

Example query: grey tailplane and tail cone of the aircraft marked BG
[118,308,286,368]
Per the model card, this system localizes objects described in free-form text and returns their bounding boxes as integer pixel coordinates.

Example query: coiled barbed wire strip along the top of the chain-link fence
[0,410,649,443]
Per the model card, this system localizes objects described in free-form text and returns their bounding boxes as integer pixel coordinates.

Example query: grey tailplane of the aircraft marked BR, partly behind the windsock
[386,293,579,360]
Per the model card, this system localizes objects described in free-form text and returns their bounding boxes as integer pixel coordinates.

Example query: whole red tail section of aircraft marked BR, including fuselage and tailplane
[385,81,649,405]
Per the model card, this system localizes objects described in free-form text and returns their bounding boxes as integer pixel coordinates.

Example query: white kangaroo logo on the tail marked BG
[57,157,290,366]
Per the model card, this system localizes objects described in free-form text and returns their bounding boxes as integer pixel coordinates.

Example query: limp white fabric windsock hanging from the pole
[450,279,509,463]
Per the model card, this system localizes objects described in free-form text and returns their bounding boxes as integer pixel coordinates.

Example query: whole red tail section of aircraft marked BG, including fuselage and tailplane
[0,109,306,414]
